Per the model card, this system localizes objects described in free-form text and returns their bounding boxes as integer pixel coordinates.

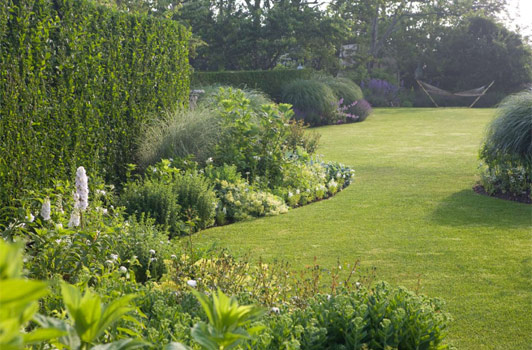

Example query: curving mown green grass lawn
[194,109,532,349]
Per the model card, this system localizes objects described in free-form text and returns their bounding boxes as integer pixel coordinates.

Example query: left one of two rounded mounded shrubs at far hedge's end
[281,80,338,126]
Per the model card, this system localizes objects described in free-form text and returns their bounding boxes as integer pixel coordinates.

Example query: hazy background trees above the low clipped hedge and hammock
[94,0,532,91]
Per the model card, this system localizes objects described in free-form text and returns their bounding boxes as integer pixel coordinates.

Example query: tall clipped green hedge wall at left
[0,0,190,207]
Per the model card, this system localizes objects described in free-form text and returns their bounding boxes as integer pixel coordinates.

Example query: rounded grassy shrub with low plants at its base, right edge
[480,91,532,196]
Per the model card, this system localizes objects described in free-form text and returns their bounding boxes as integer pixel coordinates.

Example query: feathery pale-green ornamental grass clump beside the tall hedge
[138,106,222,167]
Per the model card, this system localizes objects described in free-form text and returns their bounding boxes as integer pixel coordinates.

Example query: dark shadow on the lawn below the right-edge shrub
[431,189,532,227]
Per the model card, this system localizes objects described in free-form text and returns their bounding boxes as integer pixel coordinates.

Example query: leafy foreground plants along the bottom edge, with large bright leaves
[0,219,450,350]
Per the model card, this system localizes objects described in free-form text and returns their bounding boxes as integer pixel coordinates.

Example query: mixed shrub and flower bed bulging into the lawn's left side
[121,87,354,231]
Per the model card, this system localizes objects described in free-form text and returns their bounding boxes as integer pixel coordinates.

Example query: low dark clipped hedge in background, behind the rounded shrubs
[191,69,313,101]
